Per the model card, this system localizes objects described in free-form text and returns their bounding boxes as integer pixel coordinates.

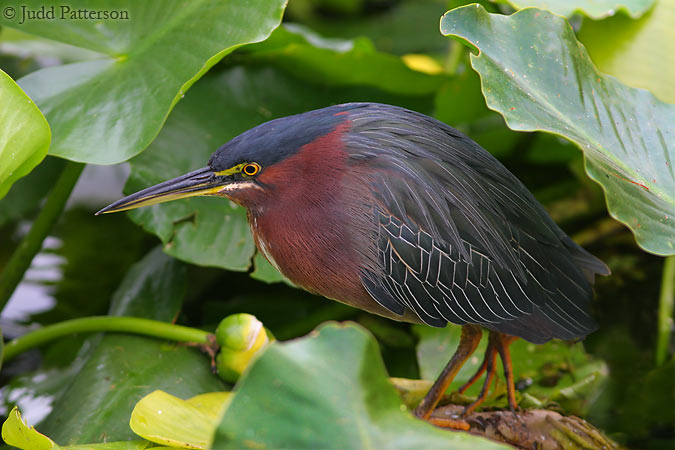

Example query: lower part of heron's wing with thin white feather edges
[362,207,595,342]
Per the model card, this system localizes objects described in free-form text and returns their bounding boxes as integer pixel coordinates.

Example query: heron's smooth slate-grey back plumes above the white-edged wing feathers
[346,105,566,270]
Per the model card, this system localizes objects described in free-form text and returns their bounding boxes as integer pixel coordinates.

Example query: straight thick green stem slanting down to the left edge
[0,161,84,311]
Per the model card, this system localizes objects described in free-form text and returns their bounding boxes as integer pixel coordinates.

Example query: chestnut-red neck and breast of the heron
[238,121,375,309]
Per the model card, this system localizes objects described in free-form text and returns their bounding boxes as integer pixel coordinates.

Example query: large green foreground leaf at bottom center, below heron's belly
[213,324,507,449]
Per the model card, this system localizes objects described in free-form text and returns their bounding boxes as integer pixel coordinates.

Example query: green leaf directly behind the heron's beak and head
[125,66,430,270]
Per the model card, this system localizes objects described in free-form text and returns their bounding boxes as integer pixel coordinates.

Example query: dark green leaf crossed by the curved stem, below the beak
[32,248,225,445]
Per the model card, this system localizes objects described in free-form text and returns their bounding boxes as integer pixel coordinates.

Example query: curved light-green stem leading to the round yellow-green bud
[2,316,209,362]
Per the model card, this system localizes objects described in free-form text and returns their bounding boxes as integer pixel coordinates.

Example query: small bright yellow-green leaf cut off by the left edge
[0,70,51,198]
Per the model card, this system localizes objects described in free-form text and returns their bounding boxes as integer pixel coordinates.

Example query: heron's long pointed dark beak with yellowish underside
[96,167,232,215]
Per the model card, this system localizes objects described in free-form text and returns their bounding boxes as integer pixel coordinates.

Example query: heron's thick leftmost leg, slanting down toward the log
[415,325,483,420]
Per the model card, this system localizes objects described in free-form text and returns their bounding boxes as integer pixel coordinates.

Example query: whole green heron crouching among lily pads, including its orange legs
[97,103,609,426]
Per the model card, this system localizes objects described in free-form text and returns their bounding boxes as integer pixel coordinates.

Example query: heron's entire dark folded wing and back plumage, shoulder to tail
[344,104,609,342]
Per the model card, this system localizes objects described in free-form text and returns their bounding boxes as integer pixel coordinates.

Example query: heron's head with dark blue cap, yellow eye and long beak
[96,105,364,214]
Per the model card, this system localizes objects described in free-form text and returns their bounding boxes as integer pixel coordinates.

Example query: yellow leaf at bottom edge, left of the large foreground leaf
[129,390,232,449]
